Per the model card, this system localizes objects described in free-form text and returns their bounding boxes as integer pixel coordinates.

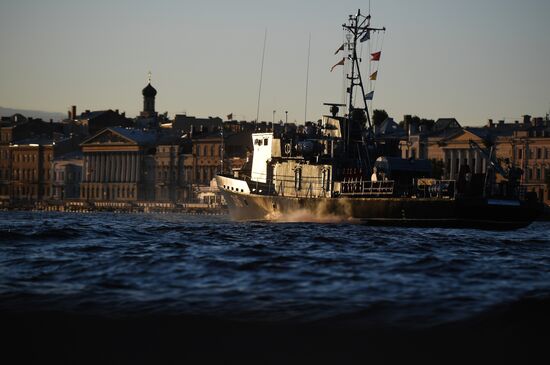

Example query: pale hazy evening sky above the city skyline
[0,0,550,125]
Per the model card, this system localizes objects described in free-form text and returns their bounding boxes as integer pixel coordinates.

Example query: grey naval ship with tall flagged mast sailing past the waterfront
[216,11,542,230]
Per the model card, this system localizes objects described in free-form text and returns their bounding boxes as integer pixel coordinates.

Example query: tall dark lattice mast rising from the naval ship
[342,10,386,134]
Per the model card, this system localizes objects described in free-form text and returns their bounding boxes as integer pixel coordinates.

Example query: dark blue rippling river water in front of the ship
[0,212,550,362]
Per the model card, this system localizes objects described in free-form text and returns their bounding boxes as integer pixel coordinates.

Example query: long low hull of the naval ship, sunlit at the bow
[217,176,540,230]
